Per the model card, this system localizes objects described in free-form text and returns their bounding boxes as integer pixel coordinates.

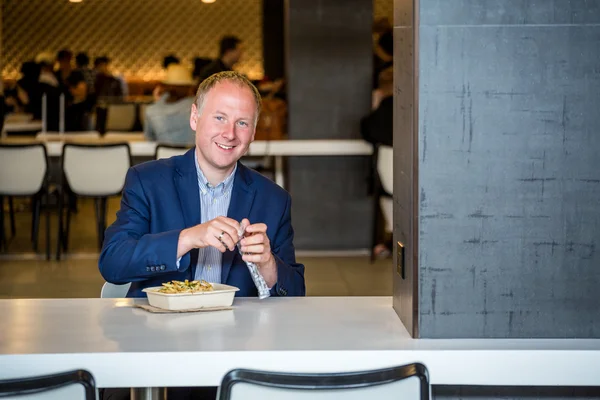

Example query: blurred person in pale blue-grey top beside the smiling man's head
[144,64,196,145]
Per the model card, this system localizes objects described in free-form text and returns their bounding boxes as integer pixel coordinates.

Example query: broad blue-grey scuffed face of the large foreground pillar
[418,0,600,338]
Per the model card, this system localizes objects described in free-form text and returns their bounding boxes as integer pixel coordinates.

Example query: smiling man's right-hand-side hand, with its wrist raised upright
[241,219,277,287]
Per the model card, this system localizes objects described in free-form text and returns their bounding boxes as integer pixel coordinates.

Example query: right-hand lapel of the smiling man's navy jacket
[221,162,256,283]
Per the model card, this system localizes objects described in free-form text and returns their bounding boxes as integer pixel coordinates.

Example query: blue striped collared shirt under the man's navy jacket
[194,150,237,283]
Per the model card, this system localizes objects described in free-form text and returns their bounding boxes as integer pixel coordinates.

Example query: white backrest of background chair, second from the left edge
[62,143,131,196]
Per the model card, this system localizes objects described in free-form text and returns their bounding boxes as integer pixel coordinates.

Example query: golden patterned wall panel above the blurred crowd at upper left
[2,0,263,79]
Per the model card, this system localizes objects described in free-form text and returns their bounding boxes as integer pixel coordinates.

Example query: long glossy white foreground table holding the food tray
[0,297,600,387]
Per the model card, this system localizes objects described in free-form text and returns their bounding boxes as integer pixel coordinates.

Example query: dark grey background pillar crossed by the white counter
[286,0,373,249]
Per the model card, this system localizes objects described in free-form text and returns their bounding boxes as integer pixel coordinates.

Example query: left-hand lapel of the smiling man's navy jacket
[173,149,202,279]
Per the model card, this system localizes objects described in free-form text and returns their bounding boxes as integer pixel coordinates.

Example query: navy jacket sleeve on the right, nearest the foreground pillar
[271,194,306,296]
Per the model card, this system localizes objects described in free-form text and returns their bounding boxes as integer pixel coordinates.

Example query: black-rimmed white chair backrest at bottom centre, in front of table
[217,364,430,400]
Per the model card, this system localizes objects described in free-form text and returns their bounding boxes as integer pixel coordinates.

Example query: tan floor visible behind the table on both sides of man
[0,198,392,298]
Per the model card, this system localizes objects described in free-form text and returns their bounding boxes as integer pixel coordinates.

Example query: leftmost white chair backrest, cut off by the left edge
[0,143,48,196]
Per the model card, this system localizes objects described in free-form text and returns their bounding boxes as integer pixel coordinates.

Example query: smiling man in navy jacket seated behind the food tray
[99,71,305,297]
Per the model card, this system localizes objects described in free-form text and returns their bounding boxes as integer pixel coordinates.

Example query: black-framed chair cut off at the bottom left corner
[0,370,96,400]
